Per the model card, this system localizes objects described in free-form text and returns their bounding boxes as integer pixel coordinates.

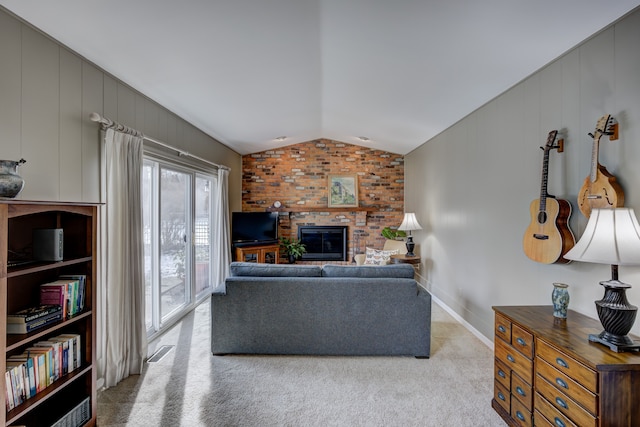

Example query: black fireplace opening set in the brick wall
[298,225,347,261]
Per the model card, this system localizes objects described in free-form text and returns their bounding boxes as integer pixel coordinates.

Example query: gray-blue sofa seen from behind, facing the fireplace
[211,262,431,357]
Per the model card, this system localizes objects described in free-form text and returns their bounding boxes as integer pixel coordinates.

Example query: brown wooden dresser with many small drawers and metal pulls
[491,306,640,427]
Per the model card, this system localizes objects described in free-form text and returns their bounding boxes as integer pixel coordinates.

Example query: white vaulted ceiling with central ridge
[0,0,640,154]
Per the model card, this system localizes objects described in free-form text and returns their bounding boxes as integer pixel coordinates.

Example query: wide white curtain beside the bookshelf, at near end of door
[102,129,147,387]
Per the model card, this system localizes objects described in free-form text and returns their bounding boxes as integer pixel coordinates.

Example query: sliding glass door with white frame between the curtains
[142,159,215,337]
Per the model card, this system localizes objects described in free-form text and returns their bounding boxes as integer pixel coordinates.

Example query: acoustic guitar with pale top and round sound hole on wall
[522,130,576,264]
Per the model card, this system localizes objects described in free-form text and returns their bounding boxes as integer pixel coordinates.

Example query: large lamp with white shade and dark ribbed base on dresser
[565,208,640,352]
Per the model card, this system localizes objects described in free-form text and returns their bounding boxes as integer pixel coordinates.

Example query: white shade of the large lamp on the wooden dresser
[564,208,640,265]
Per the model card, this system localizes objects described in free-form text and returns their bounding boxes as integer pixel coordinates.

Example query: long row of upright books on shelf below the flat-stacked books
[5,334,82,411]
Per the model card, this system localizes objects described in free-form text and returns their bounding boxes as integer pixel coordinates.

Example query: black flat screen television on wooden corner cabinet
[231,212,278,246]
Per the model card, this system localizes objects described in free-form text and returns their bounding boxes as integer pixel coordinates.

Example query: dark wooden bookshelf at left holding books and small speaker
[0,203,98,426]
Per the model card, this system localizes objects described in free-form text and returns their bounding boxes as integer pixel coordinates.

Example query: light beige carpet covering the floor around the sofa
[98,303,504,427]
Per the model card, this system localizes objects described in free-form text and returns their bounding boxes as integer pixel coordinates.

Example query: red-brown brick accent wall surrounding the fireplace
[242,139,404,263]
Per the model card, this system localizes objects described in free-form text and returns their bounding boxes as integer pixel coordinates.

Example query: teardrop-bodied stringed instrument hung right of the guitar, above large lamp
[578,114,624,218]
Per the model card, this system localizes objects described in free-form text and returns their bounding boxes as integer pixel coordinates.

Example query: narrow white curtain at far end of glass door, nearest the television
[213,167,231,293]
